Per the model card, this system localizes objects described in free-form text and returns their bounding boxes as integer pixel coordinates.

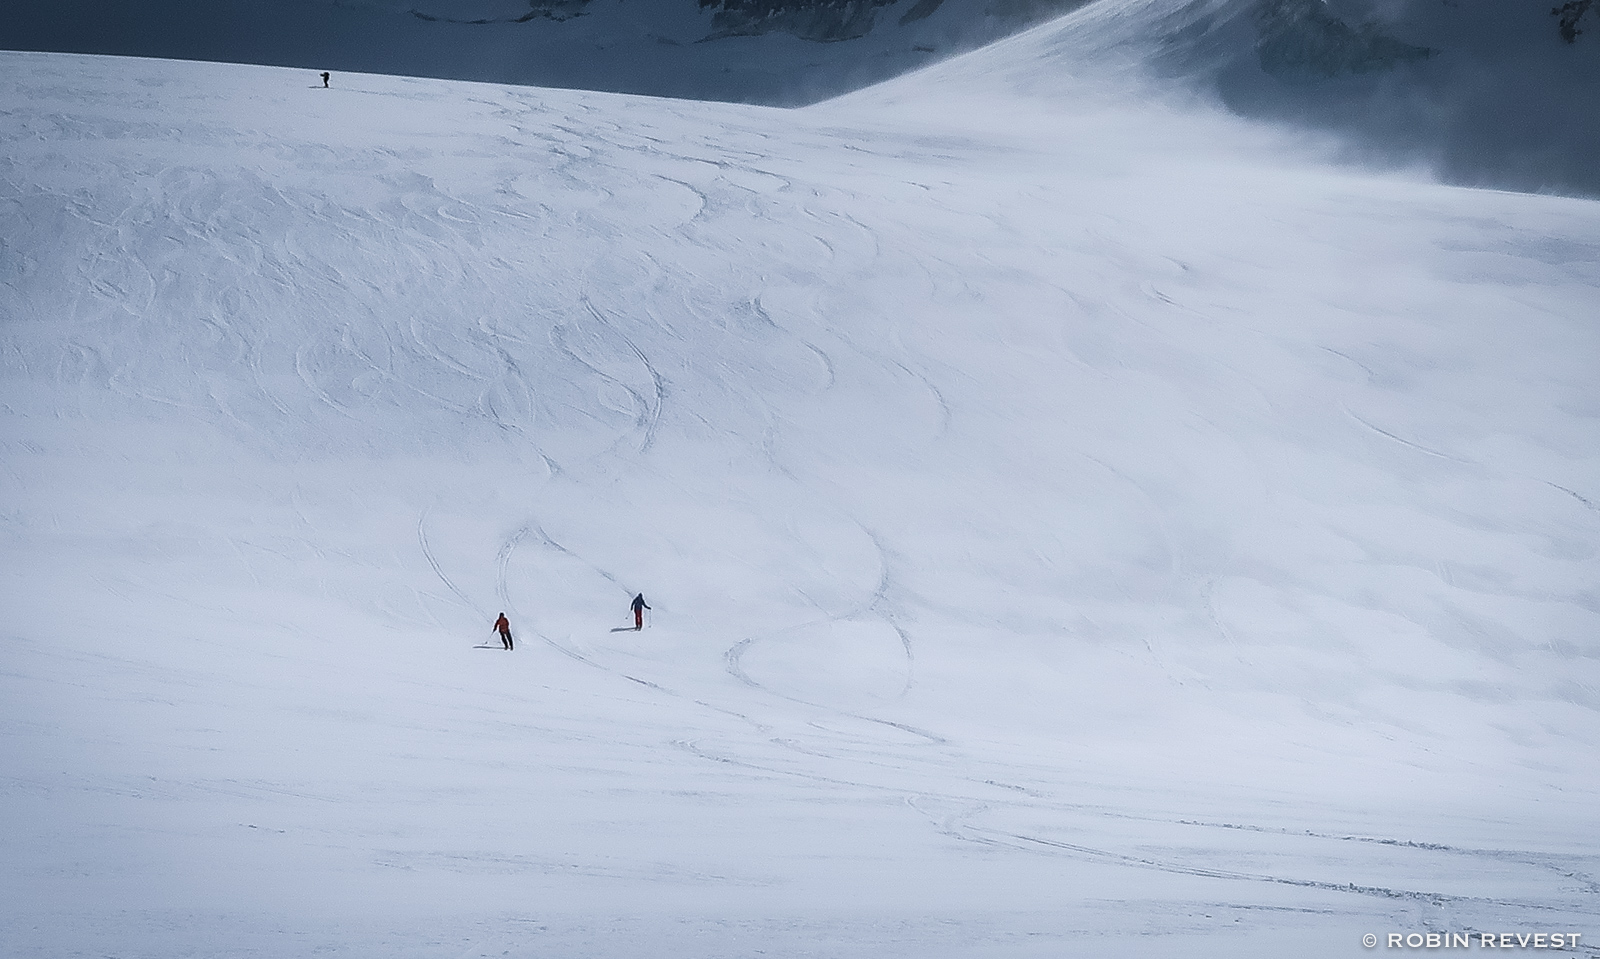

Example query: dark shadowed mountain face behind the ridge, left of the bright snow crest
[0,0,1085,106]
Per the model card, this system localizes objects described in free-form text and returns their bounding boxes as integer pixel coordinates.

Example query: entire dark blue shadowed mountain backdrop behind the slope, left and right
[0,0,1600,195]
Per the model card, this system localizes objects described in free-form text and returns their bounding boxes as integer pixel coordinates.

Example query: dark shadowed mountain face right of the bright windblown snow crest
[1206,0,1600,195]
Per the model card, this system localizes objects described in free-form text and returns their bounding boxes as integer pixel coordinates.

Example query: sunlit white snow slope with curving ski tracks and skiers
[0,24,1600,957]
